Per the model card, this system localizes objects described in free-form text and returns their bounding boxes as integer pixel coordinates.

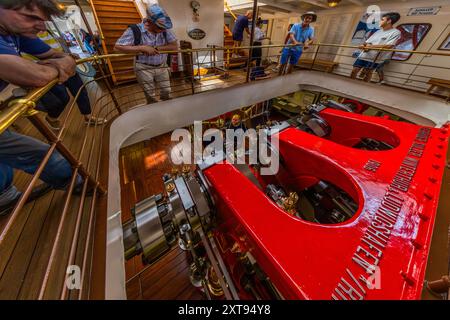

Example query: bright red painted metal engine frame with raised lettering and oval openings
[204,109,449,299]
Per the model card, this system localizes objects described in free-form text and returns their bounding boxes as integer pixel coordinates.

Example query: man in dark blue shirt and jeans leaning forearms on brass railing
[0,0,87,216]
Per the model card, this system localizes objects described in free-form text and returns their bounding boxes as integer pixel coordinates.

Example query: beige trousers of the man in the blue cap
[134,62,172,103]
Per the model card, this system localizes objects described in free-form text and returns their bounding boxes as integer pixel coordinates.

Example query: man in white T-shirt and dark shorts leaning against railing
[351,12,401,82]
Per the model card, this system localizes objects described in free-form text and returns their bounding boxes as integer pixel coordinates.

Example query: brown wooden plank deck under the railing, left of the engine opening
[0,79,112,299]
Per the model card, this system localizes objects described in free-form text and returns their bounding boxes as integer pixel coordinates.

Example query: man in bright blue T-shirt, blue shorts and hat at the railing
[279,11,317,75]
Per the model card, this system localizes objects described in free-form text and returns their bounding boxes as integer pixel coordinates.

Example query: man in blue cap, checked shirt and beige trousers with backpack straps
[114,5,178,103]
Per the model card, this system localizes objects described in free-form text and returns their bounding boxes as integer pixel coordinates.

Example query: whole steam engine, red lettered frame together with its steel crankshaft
[124,105,449,300]
